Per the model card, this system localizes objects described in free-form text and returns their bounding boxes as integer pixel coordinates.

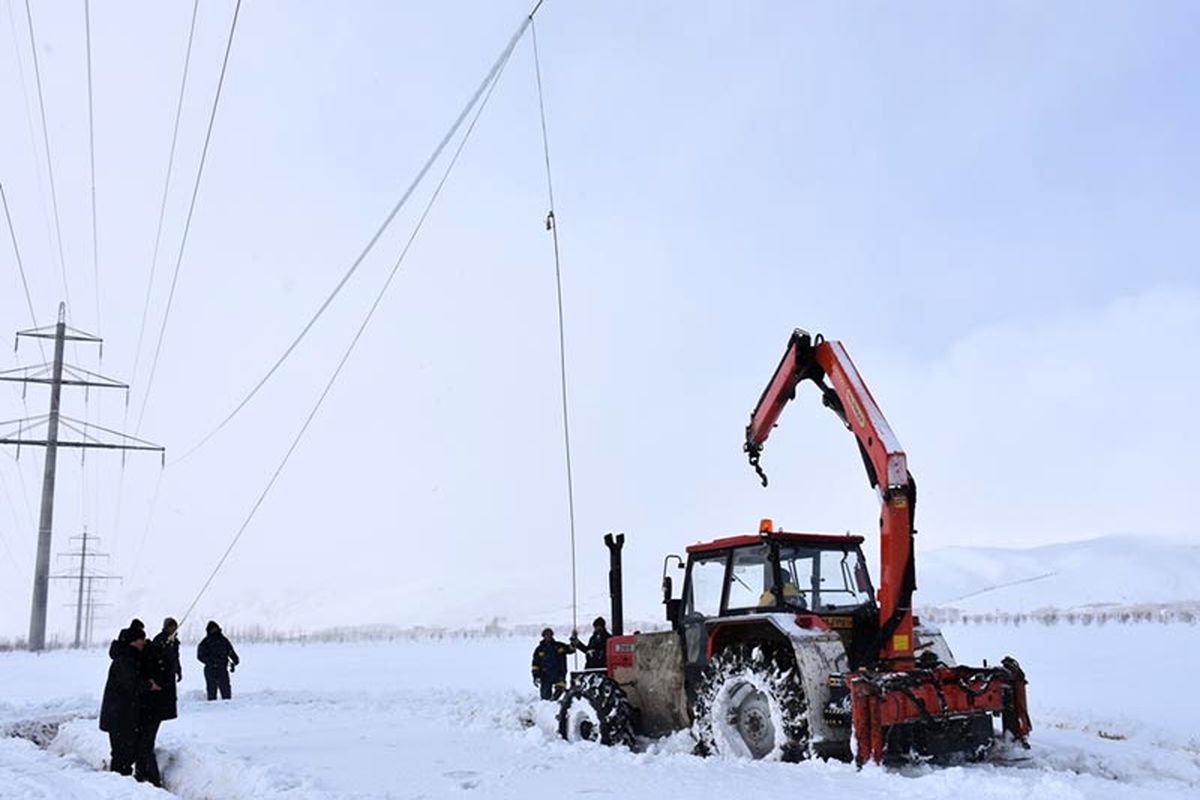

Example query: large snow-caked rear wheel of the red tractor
[692,644,809,762]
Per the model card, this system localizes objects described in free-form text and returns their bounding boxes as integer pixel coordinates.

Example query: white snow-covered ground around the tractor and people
[0,625,1200,800]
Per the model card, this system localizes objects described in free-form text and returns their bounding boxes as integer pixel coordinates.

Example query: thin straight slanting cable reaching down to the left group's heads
[179,23,518,626]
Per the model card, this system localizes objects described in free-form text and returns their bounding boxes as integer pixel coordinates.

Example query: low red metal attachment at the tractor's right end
[845,657,1032,765]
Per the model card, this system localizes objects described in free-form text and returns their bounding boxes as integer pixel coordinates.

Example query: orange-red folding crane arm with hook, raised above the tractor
[745,329,917,668]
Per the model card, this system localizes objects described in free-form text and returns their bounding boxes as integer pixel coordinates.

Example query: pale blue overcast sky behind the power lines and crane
[0,0,1200,636]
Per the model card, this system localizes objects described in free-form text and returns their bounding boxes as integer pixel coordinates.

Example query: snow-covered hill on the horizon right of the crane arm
[917,536,1200,612]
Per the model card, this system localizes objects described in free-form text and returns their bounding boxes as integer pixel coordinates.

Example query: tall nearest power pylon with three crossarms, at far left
[0,303,167,650]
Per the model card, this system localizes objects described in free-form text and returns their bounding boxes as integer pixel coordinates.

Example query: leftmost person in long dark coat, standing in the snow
[100,628,149,775]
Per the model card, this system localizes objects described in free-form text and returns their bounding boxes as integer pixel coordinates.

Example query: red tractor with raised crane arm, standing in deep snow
[558,330,1031,764]
